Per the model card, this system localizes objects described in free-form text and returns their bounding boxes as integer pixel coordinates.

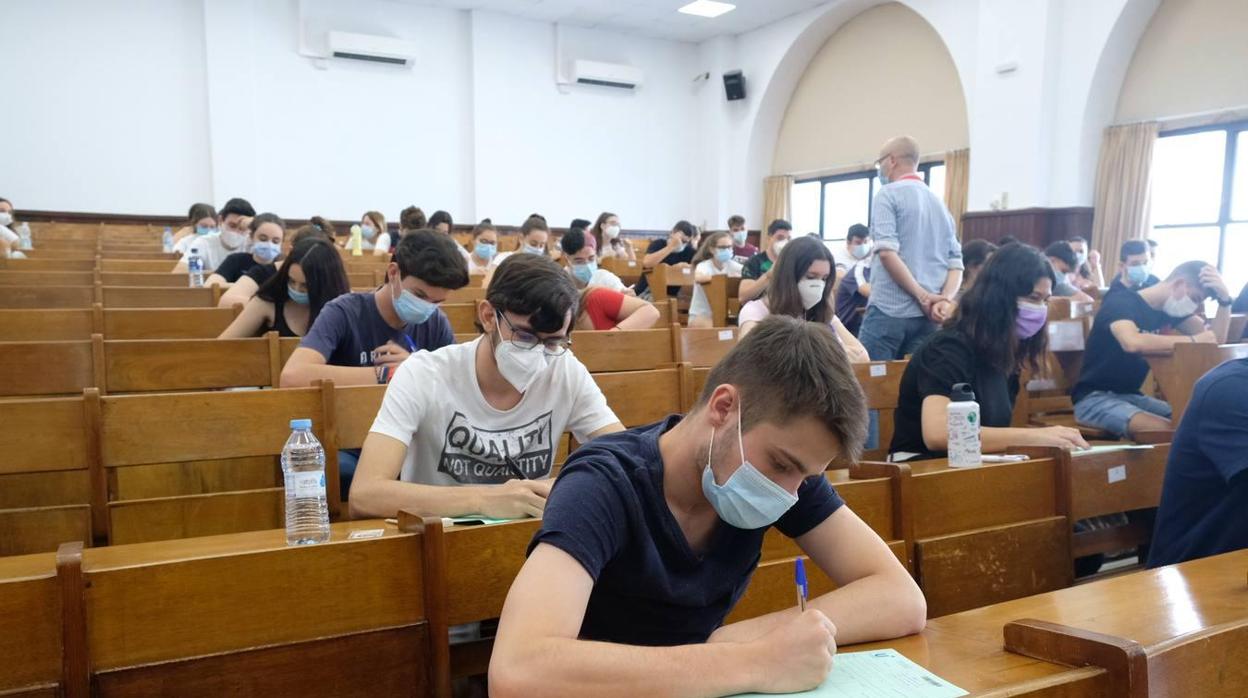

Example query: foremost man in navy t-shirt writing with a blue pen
[489,316,926,697]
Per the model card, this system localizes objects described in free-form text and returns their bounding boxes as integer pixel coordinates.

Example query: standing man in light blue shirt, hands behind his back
[859,136,962,361]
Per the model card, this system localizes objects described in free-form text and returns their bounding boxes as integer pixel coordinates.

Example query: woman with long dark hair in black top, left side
[220,237,351,338]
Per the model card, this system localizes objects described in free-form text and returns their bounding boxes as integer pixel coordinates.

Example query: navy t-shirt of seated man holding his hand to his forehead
[1071,286,1182,402]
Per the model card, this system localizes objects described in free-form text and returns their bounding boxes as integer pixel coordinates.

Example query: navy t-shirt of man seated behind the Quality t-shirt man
[300,291,456,366]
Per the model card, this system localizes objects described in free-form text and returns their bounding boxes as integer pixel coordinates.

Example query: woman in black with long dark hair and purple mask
[889,245,1087,461]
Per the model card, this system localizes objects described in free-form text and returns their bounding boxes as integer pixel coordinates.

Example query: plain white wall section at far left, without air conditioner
[0,0,210,214]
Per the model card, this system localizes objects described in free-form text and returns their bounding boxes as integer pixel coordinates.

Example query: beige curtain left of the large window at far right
[1092,122,1157,281]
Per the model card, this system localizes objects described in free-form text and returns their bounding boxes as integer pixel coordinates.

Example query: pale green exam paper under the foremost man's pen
[736,649,967,698]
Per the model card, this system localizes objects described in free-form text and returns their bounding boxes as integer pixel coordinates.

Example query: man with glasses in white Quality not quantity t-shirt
[351,253,624,518]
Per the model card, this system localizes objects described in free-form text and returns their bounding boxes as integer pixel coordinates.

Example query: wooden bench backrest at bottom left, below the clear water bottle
[69,524,446,697]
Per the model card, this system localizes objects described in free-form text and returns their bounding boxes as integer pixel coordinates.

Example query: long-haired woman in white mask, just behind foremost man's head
[736,235,870,362]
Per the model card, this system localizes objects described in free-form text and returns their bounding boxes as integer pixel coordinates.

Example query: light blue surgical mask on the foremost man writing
[703,411,797,531]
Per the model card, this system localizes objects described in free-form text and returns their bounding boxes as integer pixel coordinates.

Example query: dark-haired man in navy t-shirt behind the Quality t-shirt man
[282,230,468,388]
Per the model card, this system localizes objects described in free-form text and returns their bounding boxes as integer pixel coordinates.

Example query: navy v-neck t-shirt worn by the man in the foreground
[529,415,844,647]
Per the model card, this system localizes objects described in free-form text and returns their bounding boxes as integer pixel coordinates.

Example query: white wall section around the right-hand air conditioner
[472,12,703,230]
